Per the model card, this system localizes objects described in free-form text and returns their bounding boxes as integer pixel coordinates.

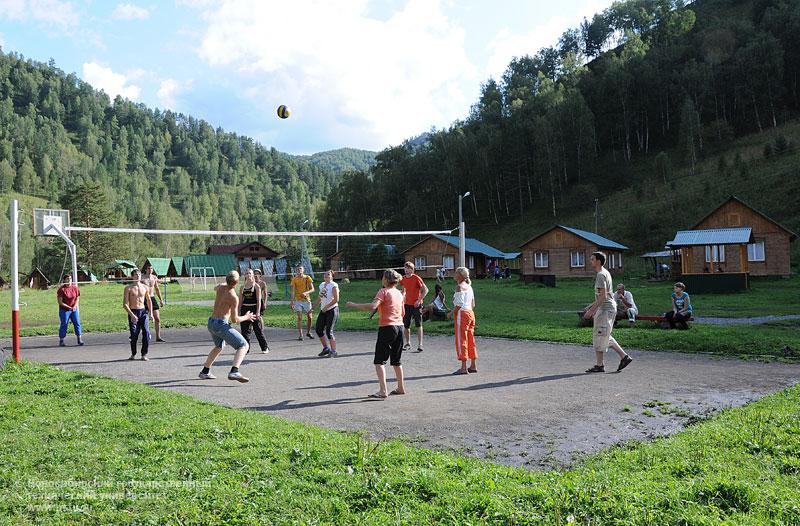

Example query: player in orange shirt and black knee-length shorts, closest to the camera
[347,269,406,400]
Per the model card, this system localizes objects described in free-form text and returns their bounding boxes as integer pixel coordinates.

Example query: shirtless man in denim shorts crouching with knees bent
[200,270,256,383]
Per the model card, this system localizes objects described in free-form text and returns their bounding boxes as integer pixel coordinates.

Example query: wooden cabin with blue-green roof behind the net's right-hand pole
[402,234,519,278]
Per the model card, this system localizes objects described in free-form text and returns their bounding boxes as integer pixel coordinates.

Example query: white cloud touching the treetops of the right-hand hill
[486,0,611,79]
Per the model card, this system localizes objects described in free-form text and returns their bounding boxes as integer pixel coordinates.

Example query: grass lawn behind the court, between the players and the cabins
[0,277,800,357]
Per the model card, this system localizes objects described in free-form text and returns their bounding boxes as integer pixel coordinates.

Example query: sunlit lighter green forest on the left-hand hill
[0,52,374,279]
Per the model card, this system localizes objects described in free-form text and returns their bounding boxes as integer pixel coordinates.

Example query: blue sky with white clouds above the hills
[0,0,611,154]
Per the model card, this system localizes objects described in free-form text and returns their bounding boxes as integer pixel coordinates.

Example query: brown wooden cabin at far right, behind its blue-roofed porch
[691,196,797,277]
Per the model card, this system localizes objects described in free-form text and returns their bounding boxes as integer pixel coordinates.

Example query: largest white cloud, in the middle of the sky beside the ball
[189,0,479,148]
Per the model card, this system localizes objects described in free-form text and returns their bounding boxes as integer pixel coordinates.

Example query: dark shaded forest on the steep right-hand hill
[321,0,800,254]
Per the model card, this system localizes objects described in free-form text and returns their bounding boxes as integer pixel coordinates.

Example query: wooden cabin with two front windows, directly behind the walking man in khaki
[520,225,628,285]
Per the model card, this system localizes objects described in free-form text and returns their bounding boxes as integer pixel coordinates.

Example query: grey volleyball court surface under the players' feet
[7,328,800,468]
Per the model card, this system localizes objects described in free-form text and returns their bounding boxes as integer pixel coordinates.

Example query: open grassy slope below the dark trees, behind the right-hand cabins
[467,121,800,268]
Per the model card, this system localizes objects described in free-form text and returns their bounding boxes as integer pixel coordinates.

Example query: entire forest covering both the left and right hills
[0,0,800,275]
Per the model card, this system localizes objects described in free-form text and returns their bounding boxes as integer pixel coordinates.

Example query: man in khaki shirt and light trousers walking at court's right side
[583,252,633,373]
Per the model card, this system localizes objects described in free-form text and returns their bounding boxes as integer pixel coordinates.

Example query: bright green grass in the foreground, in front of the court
[0,362,800,526]
